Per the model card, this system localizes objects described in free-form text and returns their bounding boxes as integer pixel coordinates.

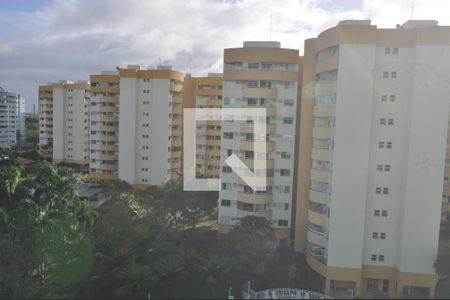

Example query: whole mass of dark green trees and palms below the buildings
[0,171,314,299]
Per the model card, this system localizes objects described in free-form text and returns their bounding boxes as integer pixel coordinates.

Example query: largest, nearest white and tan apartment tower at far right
[295,21,450,297]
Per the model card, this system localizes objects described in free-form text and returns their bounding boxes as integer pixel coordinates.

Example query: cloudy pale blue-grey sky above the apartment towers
[0,0,450,111]
